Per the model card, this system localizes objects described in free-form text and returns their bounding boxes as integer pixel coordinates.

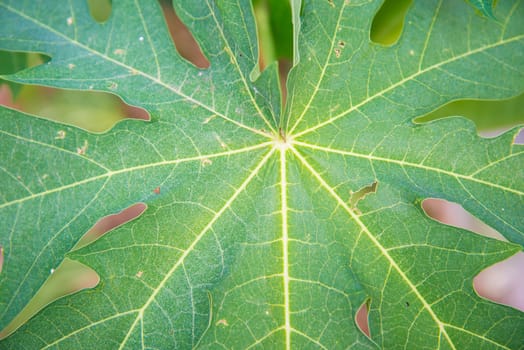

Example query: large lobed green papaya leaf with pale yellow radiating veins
[0,0,524,349]
